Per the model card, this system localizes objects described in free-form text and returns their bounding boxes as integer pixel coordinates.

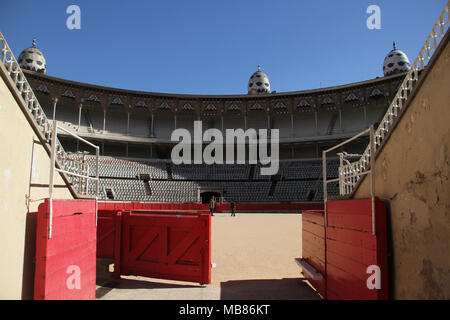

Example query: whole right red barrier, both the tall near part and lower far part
[302,199,388,300]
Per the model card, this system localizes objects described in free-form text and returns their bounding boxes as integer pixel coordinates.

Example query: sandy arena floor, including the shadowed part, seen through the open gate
[97,213,320,300]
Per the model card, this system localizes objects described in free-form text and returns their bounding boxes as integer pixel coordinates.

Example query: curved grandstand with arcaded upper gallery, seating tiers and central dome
[19,55,405,202]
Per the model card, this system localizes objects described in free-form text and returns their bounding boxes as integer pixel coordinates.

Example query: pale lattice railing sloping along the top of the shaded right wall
[339,1,450,195]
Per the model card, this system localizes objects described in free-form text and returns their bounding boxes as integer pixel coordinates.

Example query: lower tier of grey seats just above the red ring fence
[87,156,339,203]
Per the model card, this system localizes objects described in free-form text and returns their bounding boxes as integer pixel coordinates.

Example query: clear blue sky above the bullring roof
[0,0,447,94]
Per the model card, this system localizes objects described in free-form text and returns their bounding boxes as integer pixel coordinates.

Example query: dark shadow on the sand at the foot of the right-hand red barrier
[220,278,321,300]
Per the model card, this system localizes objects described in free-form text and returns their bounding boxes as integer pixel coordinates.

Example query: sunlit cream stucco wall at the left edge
[0,70,72,299]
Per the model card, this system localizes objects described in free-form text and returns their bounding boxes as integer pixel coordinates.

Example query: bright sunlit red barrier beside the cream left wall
[34,199,97,300]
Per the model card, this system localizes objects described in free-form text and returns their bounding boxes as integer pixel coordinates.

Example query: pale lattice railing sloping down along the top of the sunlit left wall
[0,32,96,197]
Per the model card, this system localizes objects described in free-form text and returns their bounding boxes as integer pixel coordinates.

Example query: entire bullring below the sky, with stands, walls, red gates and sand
[0,3,450,300]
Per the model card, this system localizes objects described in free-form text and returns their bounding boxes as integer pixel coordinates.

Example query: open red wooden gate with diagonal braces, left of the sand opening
[97,210,211,284]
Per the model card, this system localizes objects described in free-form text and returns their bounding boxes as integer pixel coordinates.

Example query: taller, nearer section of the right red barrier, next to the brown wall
[326,199,388,300]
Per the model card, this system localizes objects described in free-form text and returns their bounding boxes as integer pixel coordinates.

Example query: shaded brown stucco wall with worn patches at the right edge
[355,38,450,299]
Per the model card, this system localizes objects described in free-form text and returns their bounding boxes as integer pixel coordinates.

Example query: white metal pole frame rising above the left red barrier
[48,121,100,239]
